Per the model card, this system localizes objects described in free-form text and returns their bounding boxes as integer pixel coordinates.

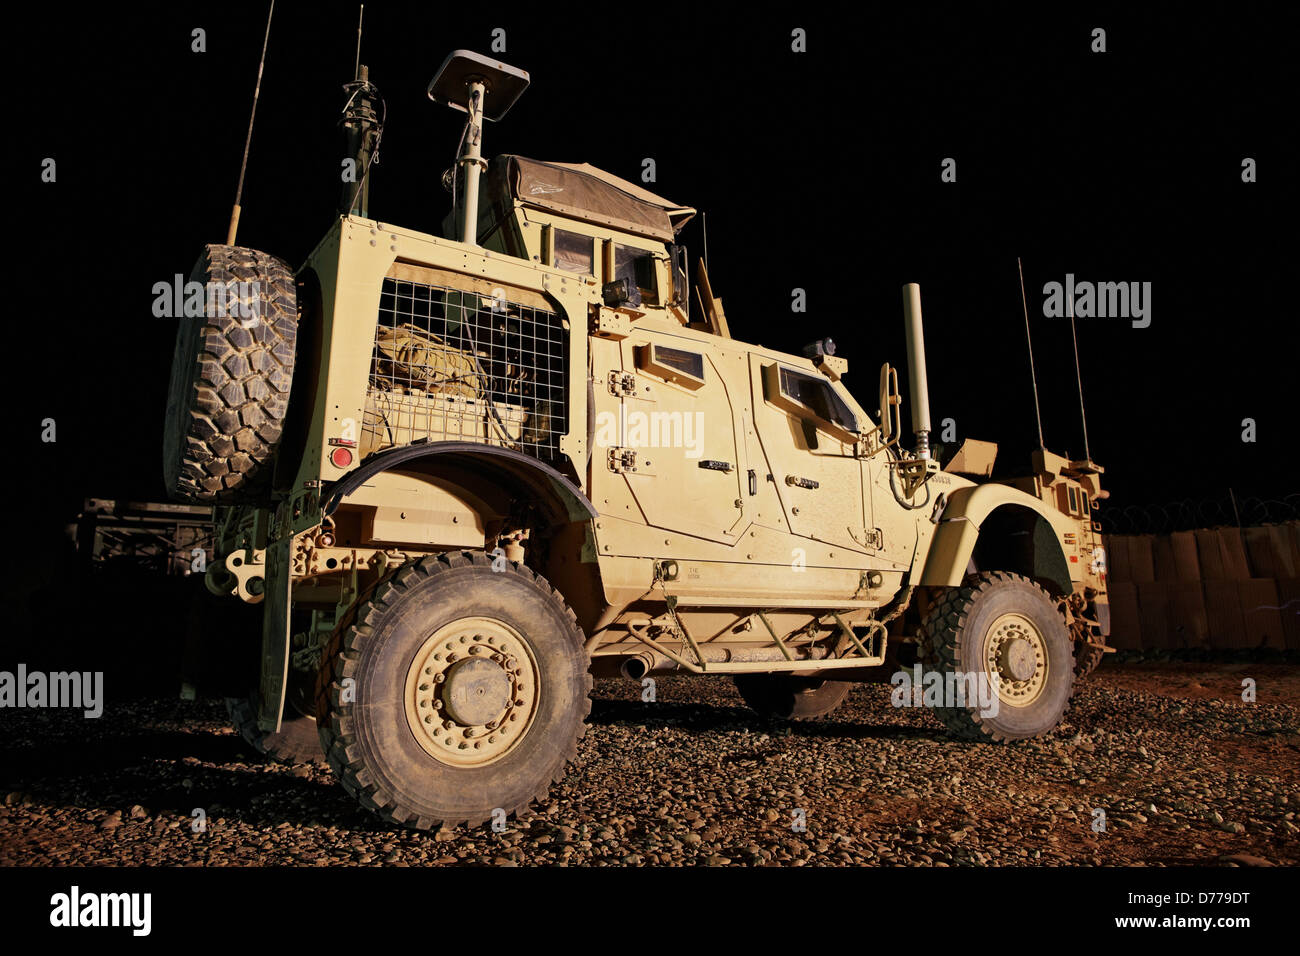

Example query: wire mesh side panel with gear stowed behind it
[361,277,568,459]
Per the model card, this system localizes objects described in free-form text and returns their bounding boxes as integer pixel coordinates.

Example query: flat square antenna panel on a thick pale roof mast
[428,49,528,246]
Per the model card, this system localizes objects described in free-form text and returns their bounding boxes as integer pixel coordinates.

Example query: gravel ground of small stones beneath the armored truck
[0,663,1300,866]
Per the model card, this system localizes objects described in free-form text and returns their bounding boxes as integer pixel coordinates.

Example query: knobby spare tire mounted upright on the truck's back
[163,246,298,503]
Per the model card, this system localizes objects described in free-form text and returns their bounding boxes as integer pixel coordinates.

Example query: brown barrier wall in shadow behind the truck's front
[1104,522,1300,650]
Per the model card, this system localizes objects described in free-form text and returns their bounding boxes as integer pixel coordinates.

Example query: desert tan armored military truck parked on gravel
[165,51,1109,829]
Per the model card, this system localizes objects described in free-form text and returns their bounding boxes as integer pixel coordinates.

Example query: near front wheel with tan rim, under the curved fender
[922,571,1074,743]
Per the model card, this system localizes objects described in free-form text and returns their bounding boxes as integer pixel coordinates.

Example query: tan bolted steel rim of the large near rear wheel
[403,618,541,767]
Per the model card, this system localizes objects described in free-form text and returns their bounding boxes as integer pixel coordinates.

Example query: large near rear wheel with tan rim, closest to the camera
[316,551,592,830]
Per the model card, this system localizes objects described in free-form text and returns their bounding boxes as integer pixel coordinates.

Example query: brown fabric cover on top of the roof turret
[501,156,696,242]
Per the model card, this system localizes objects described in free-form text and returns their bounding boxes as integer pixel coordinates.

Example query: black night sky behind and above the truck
[3,0,1296,554]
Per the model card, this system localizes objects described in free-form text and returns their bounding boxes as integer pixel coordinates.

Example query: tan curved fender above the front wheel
[919,485,1083,593]
